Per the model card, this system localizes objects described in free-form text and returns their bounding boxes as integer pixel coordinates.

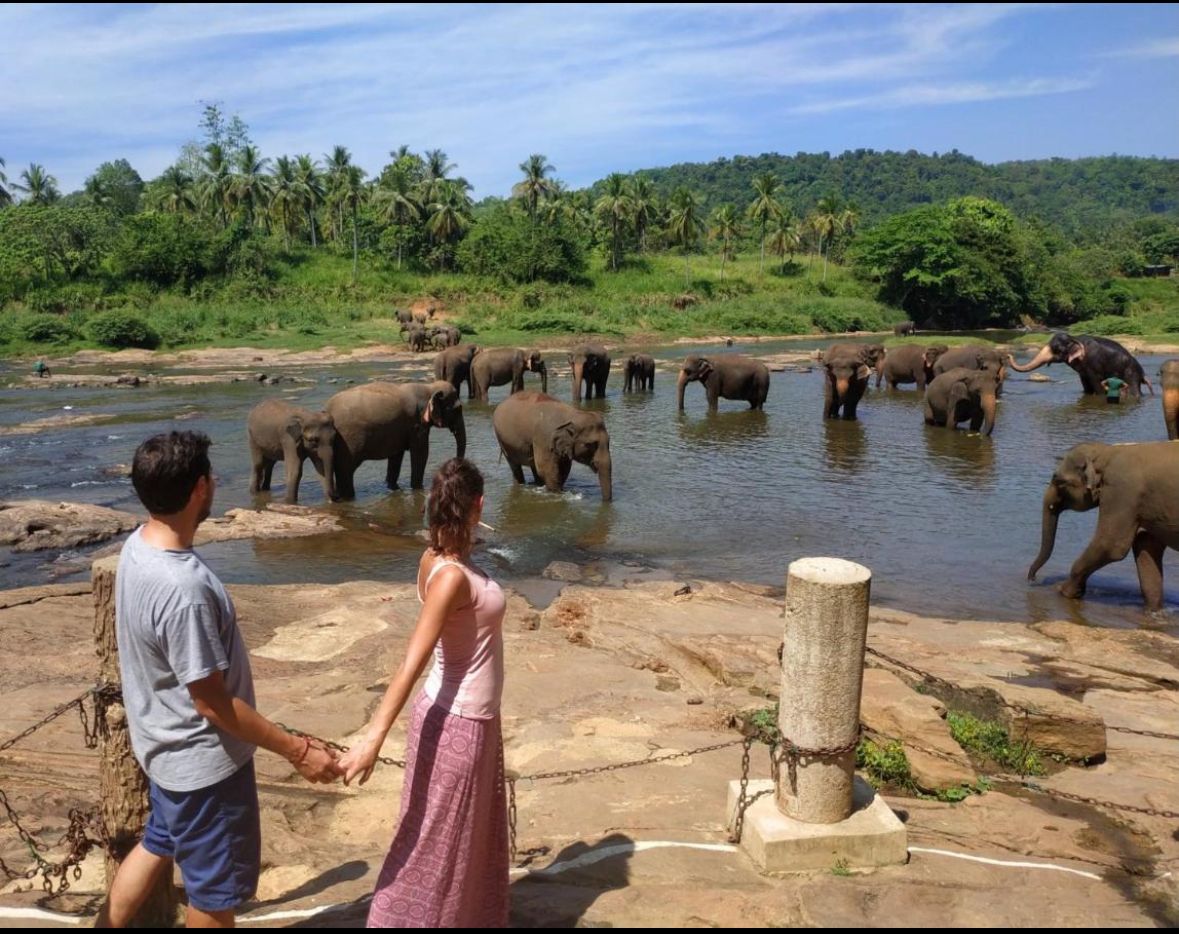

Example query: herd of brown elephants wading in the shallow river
[248,333,1179,610]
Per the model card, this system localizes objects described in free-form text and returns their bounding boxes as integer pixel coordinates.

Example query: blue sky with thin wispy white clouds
[0,4,1179,197]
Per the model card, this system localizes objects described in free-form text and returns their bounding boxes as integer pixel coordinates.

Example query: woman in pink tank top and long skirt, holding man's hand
[340,458,508,927]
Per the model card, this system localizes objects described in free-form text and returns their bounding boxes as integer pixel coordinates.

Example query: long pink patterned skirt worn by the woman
[368,691,508,927]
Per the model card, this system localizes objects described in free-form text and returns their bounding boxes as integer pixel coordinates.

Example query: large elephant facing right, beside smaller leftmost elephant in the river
[324,380,467,499]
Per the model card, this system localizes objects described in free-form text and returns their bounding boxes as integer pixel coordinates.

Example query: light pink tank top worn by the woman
[417,558,507,719]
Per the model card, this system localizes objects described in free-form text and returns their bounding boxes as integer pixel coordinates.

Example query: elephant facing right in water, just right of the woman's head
[492,392,613,502]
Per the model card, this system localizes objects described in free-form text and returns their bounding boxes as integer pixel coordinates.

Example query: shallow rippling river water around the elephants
[0,341,1179,629]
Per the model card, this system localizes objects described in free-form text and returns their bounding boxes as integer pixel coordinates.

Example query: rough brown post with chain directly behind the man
[91,555,179,927]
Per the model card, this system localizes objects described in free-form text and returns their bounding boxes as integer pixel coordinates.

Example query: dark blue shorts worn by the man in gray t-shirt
[143,759,262,912]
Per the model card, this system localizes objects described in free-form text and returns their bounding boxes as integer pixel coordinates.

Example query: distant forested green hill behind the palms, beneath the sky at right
[594,150,1179,243]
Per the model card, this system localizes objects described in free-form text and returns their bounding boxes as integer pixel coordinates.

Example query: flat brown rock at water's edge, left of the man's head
[0,500,140,552]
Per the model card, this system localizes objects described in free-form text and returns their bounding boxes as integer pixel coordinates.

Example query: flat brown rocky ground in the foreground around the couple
[0,568,1179,927]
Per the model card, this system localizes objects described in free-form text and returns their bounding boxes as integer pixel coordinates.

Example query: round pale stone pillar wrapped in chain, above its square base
[777,558,872,824]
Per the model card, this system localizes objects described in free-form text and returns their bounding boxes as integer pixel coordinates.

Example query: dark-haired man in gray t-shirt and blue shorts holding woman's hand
[98,432,340,927]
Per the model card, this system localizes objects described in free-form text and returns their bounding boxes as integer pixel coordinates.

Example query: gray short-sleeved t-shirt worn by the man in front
[114,526,255,791]
